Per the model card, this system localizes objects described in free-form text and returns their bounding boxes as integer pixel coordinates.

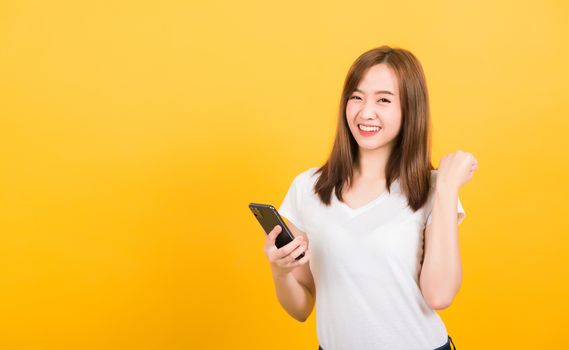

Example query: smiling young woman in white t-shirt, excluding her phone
[264,46,478,350]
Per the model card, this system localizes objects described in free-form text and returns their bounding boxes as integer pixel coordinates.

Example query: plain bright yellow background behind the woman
[0,0,569,350]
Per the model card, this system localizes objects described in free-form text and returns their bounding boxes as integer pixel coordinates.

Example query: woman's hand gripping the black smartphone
[264,225,310,275]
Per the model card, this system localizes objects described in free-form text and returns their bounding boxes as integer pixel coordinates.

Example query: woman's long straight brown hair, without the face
[313,45,434,211]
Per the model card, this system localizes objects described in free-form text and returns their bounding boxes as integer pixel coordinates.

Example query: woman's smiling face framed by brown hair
[346,63,401,150]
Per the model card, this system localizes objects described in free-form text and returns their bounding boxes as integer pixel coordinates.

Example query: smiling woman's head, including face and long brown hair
[316,46,433,210]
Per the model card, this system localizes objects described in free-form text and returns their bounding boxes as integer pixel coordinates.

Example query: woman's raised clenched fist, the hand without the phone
[436,150,478,192]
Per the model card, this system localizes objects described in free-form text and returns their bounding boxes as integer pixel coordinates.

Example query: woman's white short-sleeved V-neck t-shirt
[279,168,466,350]
